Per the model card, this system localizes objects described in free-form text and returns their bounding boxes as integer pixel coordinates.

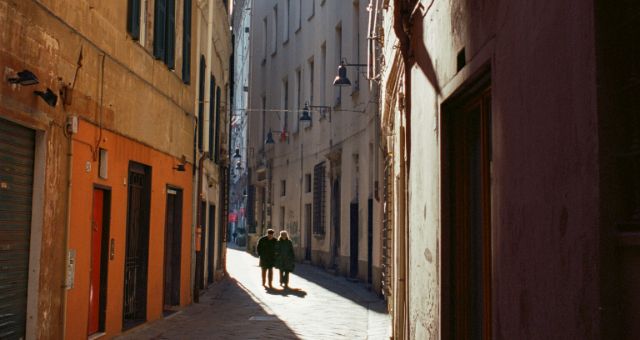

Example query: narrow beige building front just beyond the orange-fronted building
[193,0,233,301]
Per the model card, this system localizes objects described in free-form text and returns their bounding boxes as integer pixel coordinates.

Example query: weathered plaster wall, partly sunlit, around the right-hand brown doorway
[384,0,599,339]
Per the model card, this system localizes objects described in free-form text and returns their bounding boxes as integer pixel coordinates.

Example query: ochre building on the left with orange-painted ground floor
[0,0,230,339]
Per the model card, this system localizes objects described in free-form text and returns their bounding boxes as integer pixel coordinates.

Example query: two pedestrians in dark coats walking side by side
[258,229,295,288]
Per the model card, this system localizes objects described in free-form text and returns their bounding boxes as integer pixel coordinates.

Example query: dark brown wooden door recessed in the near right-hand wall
[442,79,491,339]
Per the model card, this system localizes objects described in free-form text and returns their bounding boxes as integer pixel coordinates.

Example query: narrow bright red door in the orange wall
[87,189,104,335]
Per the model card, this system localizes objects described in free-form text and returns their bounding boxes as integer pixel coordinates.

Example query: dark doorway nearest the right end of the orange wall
[163,187,182,313]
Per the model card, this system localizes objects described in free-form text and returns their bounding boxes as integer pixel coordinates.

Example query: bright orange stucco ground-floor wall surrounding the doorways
[66,120,192,339]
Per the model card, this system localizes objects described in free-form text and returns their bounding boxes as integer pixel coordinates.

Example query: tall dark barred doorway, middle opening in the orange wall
[122,162,151,330]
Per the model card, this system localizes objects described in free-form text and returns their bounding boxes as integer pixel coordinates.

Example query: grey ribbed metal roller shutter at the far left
[0,119,35,339]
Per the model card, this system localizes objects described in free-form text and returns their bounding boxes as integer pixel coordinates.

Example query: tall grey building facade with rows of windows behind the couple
[245,0,382,291]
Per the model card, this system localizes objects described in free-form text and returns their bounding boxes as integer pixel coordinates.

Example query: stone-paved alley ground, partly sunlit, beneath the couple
[118,244,391,340]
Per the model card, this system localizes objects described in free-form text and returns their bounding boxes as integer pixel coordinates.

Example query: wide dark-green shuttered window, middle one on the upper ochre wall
[153,0,176,70]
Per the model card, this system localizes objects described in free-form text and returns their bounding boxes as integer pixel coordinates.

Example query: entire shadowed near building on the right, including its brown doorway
[371,0,640,339]
